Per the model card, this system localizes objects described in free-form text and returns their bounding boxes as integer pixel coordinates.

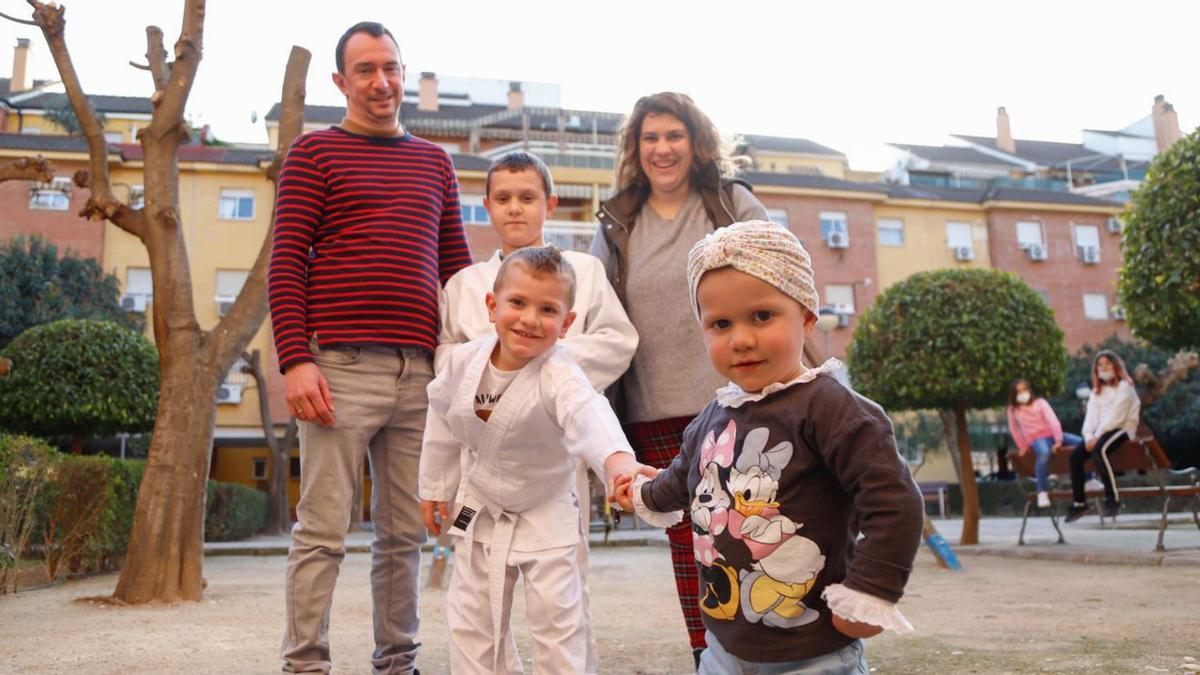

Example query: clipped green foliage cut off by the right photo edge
[1117,129,1200,350]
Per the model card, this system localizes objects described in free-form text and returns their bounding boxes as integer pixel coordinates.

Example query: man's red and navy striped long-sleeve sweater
[268,127,472,371]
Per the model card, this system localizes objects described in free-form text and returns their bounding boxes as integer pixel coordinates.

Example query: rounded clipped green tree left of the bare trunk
[0,319,158,453]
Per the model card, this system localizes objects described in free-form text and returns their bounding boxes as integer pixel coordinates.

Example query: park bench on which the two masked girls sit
[1009,425,1200,551]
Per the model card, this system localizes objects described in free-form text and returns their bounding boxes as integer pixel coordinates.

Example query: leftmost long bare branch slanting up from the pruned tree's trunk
[29,0,145,239]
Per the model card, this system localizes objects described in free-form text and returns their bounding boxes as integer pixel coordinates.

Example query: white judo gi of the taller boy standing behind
[434,251,637,673]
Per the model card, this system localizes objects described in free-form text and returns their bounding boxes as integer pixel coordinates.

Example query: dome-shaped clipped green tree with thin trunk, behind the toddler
[847,269,1067,544]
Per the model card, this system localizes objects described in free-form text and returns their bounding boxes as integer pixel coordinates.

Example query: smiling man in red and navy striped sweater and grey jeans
[268,22,472,674]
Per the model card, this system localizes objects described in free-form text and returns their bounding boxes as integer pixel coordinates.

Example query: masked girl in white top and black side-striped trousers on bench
[1067,350,1141,522]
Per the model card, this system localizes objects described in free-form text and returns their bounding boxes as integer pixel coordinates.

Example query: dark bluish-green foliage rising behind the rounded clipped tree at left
[0,235,143,348]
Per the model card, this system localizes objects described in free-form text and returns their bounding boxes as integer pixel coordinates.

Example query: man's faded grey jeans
[282,340,433,673]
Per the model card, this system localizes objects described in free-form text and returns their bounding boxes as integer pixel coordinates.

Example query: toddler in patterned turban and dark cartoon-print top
[614,221,924,674]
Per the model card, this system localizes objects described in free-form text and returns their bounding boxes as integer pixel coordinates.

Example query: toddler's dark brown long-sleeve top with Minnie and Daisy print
[641,375,924,662]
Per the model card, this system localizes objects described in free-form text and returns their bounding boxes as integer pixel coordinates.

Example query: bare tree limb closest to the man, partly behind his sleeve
[212,47,312,368]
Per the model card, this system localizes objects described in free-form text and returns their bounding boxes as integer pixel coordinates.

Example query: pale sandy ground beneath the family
[0,546,1200,675]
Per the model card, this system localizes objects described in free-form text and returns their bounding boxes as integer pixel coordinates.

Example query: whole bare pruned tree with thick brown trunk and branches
[5,0,310,603]
